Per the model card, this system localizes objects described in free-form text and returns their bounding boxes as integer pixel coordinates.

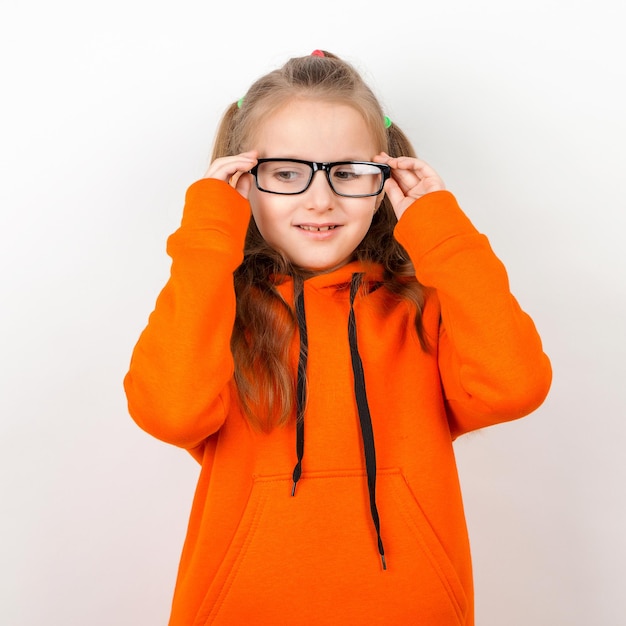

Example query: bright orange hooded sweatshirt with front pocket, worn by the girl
[124,179,551,626]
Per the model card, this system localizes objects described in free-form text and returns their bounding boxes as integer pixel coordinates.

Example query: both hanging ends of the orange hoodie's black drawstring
[291,274,387,570]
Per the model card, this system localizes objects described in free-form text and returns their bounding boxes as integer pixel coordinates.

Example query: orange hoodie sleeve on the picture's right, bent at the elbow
[395,191,552,438]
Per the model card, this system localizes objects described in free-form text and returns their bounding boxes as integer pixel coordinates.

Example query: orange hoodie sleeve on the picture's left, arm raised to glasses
[124,179,250,446]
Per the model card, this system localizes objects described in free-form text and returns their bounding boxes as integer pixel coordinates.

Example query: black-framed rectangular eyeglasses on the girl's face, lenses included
[250,159,391,198]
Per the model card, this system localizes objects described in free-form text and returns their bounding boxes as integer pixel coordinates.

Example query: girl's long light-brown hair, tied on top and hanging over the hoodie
[212,52,426,429]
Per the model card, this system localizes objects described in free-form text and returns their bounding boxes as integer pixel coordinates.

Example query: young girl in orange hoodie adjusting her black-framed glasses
[125,51,551,626]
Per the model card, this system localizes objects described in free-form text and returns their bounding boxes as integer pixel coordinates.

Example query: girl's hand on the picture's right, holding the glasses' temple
[374,152,446,219]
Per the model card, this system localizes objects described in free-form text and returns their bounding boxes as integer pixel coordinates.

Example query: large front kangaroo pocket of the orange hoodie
[195,470,467,626]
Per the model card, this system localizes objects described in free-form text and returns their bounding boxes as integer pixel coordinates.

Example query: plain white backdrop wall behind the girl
[0,0,626,626]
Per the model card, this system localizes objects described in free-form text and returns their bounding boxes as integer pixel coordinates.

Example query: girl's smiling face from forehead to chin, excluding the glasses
[244,100,382,272]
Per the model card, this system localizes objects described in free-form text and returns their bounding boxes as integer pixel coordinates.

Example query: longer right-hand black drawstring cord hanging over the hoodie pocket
[348,274,387,570]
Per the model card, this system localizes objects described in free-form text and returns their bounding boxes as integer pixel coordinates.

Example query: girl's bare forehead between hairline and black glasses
[250,99,381,161]
